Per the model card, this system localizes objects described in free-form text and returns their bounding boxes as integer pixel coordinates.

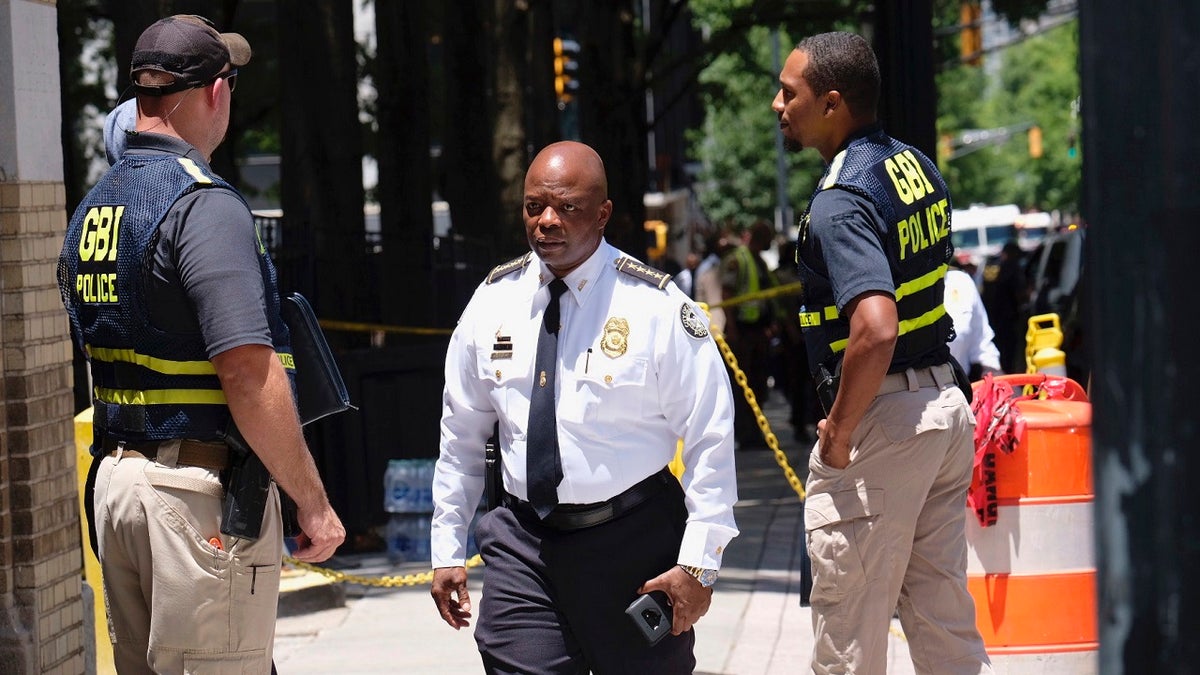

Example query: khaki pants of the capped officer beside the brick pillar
[95,444,283,675]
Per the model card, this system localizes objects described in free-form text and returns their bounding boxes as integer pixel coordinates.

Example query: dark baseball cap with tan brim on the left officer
[130,14,251,96]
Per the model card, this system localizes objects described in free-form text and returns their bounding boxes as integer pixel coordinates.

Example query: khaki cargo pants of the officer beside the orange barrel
[804,383,991,675]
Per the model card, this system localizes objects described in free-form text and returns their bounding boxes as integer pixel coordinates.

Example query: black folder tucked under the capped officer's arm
[281,293,356,424]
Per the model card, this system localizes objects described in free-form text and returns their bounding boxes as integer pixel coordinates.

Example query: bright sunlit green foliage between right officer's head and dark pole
[937,20,1082,211]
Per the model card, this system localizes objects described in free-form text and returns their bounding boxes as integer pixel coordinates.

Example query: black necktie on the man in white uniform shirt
[526,279,566,518]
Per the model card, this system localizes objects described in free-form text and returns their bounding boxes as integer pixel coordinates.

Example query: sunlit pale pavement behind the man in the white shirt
[275,393,913,675]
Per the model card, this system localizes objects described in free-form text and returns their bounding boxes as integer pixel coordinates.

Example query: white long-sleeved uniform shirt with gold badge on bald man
[432,241,738,569]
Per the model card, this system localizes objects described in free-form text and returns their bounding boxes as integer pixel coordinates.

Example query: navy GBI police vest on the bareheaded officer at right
[797,130,954,372]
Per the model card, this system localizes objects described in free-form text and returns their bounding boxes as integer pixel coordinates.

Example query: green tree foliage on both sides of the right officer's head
[689,0,1081,227]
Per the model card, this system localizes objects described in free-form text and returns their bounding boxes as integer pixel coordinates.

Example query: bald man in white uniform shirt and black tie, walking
[432,142,737,674]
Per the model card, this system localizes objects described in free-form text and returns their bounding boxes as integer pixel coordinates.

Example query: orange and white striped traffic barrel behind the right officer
[966,375,1099,675]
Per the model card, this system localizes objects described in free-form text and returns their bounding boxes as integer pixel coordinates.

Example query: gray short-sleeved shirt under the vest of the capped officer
[126,132,272,358]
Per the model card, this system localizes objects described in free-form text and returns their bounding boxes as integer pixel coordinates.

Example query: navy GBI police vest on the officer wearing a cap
[58,154,295,442]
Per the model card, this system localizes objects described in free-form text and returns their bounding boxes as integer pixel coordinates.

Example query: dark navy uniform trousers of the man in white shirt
[475,473,696,675]
